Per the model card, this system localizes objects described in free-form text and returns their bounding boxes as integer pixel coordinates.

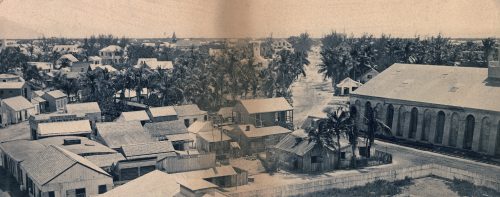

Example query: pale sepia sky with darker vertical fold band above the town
[0,0,500,38]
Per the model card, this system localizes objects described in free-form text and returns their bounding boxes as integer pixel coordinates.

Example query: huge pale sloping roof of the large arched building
[351,64,500,112]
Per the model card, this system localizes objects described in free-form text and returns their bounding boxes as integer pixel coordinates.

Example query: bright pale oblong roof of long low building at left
[37,120,92,136]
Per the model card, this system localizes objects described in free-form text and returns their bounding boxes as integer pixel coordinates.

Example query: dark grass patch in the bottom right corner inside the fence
[446,178,500,196]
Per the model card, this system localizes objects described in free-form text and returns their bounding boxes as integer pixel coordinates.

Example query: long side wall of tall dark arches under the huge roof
[351,97,500,156]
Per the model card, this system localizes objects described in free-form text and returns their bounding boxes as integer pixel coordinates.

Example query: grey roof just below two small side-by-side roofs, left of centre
[144,120,188,137]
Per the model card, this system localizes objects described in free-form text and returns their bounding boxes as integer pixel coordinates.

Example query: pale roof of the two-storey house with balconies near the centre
[240,97,293,114]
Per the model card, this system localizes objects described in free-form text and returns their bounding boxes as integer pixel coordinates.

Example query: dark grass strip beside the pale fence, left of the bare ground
[296,177,413,197]
